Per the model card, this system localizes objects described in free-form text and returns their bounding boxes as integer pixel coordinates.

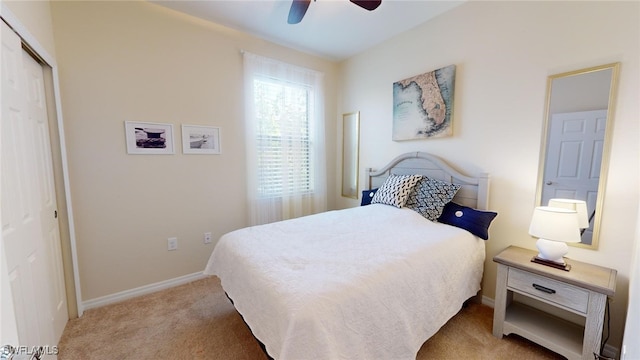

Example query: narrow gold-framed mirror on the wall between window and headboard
[342,111,360,199]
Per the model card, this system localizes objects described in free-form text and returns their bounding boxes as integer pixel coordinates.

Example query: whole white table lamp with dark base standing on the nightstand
[529,206,586,271]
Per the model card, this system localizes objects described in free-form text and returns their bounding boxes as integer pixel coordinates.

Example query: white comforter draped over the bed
[205,204,485,360]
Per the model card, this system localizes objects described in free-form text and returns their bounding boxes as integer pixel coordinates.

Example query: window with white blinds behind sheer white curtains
[244,52,327,225]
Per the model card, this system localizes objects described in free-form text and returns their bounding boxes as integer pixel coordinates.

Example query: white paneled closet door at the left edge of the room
[0,22,68,347]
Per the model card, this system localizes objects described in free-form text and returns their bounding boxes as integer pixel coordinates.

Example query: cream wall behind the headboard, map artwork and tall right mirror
[337,2,640,348]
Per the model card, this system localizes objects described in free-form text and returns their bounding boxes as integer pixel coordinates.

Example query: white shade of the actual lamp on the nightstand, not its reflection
[529,206,581,242]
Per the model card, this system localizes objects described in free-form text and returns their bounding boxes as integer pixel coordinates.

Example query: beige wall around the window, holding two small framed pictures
[51,1,337,301]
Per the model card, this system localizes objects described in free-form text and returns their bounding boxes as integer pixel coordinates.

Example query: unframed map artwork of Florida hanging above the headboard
[392,65,456,141]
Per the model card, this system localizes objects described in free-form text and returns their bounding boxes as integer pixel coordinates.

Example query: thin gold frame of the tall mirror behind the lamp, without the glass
[536,62,620,250]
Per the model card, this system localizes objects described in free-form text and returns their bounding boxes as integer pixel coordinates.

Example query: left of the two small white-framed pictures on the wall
[124,121,175,155]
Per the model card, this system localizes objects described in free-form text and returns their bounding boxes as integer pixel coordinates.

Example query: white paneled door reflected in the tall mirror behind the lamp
[542,110,607,243]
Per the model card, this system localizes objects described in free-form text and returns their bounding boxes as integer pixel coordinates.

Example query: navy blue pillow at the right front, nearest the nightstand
[438,202,498,240]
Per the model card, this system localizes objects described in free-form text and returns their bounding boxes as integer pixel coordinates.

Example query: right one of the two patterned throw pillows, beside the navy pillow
[405,177,461,221]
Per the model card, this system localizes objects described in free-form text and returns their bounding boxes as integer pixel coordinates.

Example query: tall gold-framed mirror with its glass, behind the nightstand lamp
[536,63,620,250]
